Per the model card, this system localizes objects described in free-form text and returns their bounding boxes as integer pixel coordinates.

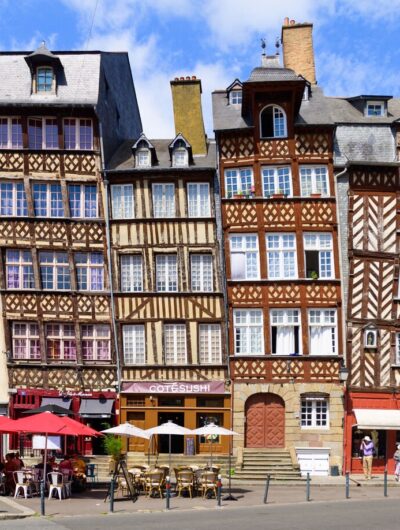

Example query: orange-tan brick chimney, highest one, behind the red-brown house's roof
[282,17,317,85]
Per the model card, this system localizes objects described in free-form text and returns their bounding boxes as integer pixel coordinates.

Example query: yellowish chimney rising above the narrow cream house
[171,76,207,155]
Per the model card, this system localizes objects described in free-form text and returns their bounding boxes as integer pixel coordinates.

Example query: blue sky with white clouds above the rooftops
[0,0,400,138]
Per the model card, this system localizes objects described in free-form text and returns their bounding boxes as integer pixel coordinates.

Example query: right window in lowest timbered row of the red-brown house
[308,309,337,355]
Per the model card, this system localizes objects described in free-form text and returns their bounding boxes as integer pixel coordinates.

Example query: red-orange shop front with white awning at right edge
[344,392,400,474]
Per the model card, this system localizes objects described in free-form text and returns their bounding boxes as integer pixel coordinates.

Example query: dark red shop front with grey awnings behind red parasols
[10,388,117,455]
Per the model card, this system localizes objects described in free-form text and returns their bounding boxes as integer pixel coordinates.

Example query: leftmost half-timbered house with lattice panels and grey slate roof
[0,45,141,453]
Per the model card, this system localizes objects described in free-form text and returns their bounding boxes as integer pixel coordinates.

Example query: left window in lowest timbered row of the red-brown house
[233,309,264,355]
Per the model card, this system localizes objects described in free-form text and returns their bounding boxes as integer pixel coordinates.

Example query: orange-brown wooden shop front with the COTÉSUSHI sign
[120,381,231,455]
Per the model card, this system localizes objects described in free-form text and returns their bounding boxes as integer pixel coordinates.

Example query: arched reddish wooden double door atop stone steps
[246,394,285,448]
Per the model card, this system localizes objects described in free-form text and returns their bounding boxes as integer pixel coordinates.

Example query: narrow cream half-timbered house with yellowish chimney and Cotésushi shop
[107,78,230,454]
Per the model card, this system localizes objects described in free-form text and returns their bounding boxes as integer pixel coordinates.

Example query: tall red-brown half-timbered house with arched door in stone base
[213,26,343,474]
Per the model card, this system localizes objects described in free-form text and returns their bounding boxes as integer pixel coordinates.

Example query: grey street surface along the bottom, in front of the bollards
[0,499,399,530]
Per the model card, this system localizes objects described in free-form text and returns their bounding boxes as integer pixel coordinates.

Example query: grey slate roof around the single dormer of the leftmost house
[0,51,115,106]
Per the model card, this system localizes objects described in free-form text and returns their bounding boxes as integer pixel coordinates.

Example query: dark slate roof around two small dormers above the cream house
[107,139,216,172]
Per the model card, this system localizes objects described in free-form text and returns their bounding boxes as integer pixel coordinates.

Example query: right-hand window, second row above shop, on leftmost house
[74,252,104,291]
